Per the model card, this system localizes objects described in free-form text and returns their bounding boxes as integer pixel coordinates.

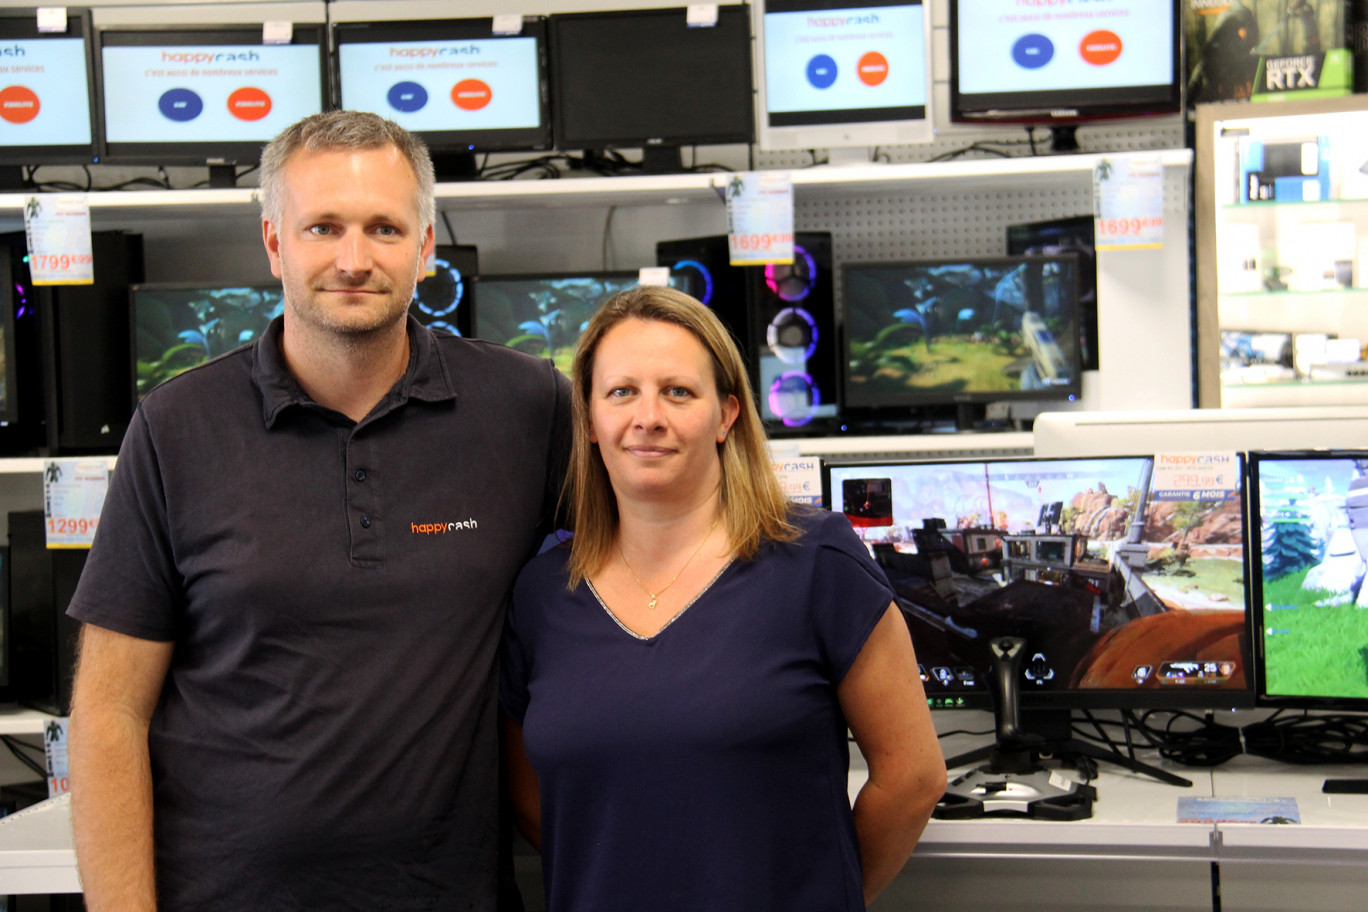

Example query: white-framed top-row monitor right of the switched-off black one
[755,0,933,149]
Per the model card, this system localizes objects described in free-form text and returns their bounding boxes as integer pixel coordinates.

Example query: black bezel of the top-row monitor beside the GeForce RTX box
[948,0,1185,126]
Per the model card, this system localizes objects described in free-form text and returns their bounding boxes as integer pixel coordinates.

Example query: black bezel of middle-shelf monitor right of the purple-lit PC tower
[840,254,1083,412]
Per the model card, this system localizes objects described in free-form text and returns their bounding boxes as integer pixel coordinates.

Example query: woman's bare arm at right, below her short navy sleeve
[836,604,945,905]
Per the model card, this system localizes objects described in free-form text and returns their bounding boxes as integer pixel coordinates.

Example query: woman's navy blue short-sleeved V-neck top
[501,511,893,912]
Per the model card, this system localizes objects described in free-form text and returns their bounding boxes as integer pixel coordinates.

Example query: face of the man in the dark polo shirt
[261,146,434,344]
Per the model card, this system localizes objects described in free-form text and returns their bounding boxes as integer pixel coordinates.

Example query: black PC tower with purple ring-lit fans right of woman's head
[655,231,840,436]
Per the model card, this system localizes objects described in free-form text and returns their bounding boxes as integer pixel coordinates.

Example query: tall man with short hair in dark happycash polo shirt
[70,112,569,912]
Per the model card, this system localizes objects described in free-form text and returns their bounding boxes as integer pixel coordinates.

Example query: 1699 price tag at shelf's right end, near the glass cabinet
[1093,156,1164,250]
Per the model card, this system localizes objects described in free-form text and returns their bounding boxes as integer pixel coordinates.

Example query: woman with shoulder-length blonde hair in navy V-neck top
[502,287,945,912]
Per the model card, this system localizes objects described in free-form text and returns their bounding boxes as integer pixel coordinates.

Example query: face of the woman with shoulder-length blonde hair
[590,319,740,500]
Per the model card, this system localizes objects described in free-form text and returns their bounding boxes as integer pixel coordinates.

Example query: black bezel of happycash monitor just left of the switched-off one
[328,16,554,155]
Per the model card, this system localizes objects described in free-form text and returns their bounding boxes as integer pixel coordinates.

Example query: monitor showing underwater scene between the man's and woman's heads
[475,271,683,376]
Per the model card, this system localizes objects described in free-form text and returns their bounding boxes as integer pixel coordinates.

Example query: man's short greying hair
[259,111,436,234]
